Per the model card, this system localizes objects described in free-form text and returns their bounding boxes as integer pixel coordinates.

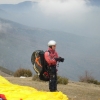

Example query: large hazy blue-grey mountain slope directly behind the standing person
[0,18,100,80]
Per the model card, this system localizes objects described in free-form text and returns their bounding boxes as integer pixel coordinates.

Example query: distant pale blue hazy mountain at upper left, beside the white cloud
[0,1,43,27]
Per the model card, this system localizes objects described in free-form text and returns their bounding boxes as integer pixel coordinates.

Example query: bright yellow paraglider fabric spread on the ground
[0,76,68,100]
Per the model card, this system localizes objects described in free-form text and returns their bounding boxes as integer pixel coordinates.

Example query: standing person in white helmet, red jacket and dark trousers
[44,40,59,92]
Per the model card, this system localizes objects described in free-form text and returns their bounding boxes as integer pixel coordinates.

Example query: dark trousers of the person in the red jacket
[49,66,57,92]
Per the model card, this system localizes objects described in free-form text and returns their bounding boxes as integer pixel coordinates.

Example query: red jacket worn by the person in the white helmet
[44,48,58,66]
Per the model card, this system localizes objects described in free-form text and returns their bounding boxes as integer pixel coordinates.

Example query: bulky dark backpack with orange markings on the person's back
[31,50,49,81]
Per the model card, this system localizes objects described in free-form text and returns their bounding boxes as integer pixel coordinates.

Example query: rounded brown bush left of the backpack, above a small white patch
[14,68,32,77]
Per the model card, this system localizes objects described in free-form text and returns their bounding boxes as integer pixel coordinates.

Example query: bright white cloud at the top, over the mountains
[39,0,86,16]
